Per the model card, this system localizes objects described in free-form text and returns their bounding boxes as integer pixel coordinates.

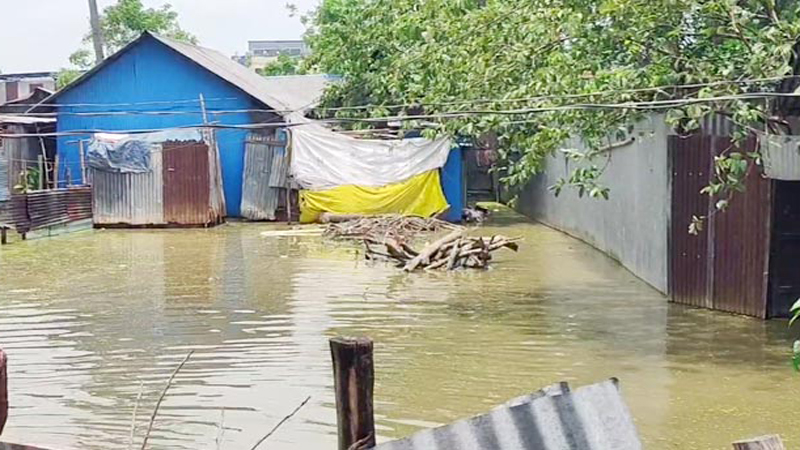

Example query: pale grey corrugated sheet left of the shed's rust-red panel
[92,151,166,226]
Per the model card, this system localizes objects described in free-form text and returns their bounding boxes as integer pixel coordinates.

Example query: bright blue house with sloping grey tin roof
[46,33,327,217]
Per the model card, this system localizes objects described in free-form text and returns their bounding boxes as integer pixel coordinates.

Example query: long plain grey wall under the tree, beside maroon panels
[518,115,671,293]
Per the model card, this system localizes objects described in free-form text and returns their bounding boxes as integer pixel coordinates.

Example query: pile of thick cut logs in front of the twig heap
[364,230,521,272]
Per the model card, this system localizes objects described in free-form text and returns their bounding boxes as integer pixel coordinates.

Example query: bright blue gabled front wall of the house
[56,39,264,217]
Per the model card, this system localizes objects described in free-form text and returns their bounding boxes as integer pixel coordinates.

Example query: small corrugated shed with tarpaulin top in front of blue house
[86,130,224,227]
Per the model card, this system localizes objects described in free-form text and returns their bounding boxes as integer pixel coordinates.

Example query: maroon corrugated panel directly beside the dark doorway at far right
[712,138,772,318]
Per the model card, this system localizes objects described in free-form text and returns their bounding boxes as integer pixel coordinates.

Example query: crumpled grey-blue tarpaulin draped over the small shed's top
[86,129,203,173]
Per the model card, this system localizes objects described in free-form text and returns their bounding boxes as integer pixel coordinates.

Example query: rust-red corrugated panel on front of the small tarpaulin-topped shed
[163,142,211,225]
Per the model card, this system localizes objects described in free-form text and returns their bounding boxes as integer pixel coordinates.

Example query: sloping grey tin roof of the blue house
[45,32,334,118]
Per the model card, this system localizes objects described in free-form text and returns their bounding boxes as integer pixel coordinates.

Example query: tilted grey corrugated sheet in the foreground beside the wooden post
[375,380,642,450]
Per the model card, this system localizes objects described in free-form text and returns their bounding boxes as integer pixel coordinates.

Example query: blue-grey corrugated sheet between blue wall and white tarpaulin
[242,133,286,220]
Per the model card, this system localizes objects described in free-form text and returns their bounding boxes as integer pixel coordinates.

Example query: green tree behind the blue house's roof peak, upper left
[57,0,197,88]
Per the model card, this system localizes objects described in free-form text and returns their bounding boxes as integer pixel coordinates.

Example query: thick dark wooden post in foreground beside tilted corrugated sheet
[330,337,375,450]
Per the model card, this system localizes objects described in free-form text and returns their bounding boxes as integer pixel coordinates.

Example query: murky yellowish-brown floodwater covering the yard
[0,212,800,450]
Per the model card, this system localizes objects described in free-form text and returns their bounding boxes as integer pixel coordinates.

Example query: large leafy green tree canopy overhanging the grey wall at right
[307,0,800,204]
